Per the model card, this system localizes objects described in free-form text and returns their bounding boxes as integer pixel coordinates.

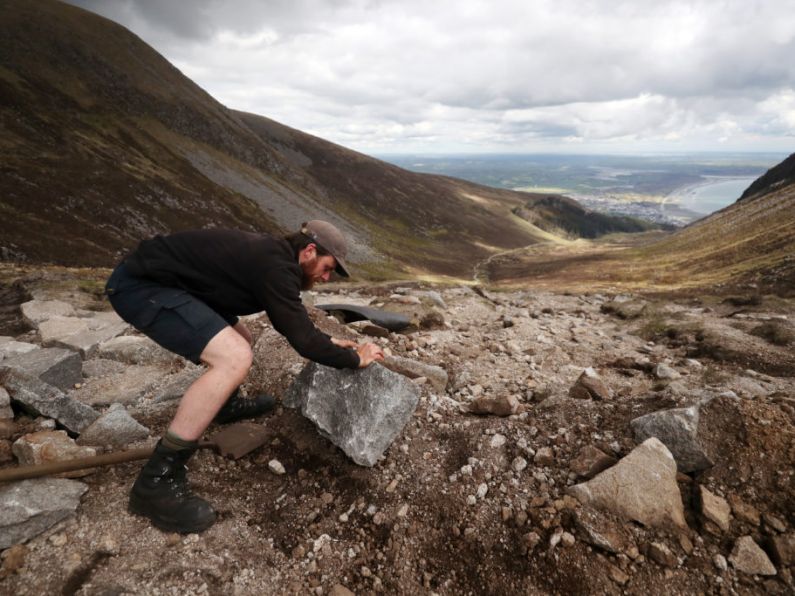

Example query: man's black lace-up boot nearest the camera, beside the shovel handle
[129,440,215,534]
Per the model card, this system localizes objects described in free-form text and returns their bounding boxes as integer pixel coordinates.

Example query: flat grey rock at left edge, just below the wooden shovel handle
[0,478,87,549]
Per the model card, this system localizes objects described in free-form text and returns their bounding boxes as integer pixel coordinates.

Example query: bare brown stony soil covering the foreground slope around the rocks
[0,272,795,595]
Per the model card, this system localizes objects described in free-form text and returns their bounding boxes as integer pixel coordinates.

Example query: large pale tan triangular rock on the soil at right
[569,438,687,528]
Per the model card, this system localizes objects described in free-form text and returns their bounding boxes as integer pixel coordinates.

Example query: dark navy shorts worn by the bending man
[105,263,237,364]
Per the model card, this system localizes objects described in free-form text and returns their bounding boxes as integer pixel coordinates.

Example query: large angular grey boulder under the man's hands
[284,362,419,466]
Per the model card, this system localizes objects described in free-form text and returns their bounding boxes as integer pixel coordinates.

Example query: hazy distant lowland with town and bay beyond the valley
[378,153,786,226]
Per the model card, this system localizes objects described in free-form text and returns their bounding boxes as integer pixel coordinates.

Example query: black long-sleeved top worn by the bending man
[125,229,359,368]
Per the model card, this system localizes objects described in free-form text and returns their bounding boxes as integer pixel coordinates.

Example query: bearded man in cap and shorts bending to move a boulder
[106,220,384,533]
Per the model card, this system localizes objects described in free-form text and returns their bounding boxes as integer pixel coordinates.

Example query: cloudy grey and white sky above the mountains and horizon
[71,0,795,155]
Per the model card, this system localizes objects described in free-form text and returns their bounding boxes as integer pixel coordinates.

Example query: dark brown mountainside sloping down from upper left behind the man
[0,0,664,278]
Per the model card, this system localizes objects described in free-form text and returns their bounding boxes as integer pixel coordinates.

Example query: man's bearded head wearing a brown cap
[287,219,349,290]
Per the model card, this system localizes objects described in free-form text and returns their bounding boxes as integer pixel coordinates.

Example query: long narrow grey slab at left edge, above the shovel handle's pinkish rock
[0,368,99,433]
